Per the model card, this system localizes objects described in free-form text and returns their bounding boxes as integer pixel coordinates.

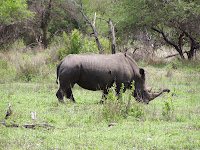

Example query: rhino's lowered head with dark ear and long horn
[133,68,170,104]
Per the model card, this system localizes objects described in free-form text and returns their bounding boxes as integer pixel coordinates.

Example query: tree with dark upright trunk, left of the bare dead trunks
[25,0,82,49]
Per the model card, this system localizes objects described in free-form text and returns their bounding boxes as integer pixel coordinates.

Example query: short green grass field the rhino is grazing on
[0,56,200,150]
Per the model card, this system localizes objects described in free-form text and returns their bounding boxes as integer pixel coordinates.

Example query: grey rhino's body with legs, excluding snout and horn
[56,53,169,103]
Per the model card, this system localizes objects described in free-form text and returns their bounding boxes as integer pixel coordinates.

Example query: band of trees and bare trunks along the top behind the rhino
[0,0,200,59]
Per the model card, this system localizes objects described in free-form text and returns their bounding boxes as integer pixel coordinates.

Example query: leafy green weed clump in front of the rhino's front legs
[102,84,144,122]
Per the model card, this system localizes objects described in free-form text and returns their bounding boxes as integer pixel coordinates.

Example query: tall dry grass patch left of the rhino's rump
[0,49,58,83]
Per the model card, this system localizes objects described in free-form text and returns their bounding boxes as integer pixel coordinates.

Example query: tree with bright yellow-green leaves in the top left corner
[0,0,33,47]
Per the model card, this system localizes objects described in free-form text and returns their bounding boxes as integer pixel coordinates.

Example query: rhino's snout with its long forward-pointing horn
[134,89,170,104]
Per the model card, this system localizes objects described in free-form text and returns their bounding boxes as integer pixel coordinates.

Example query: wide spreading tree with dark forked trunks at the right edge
[114,0,200,59]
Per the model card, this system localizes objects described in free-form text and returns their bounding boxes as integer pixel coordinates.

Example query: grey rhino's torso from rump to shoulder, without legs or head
[59,53,133,90]
